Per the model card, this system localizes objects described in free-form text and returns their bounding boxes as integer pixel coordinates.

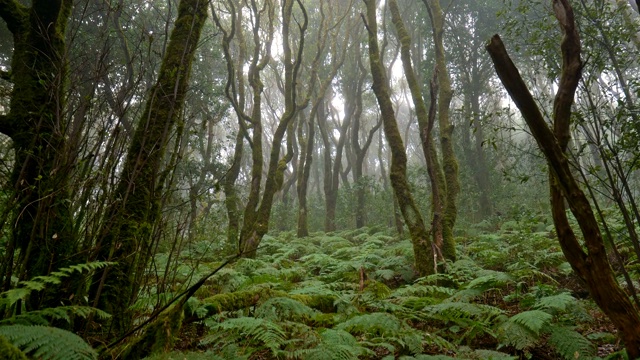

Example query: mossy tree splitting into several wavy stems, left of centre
[214,0,308,257]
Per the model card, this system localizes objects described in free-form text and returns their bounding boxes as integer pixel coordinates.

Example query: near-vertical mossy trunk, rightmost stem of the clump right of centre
[422,0,460,261]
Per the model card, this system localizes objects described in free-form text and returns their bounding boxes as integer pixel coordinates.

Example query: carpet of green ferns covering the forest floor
[144,222,622,360]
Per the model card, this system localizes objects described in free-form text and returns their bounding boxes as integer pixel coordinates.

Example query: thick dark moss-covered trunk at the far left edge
[0,0,80,308]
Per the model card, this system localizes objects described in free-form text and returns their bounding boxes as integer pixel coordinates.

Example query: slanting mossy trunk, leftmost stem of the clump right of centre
[364,0,435,275]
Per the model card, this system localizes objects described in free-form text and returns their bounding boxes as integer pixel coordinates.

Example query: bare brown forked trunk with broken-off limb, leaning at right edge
[487,0,640,359]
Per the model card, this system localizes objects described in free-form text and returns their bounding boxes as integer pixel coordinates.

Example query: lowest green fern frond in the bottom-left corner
[0,325,98,360]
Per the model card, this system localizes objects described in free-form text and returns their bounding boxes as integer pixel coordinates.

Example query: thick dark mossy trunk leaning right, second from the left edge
[91,0,207,333]
